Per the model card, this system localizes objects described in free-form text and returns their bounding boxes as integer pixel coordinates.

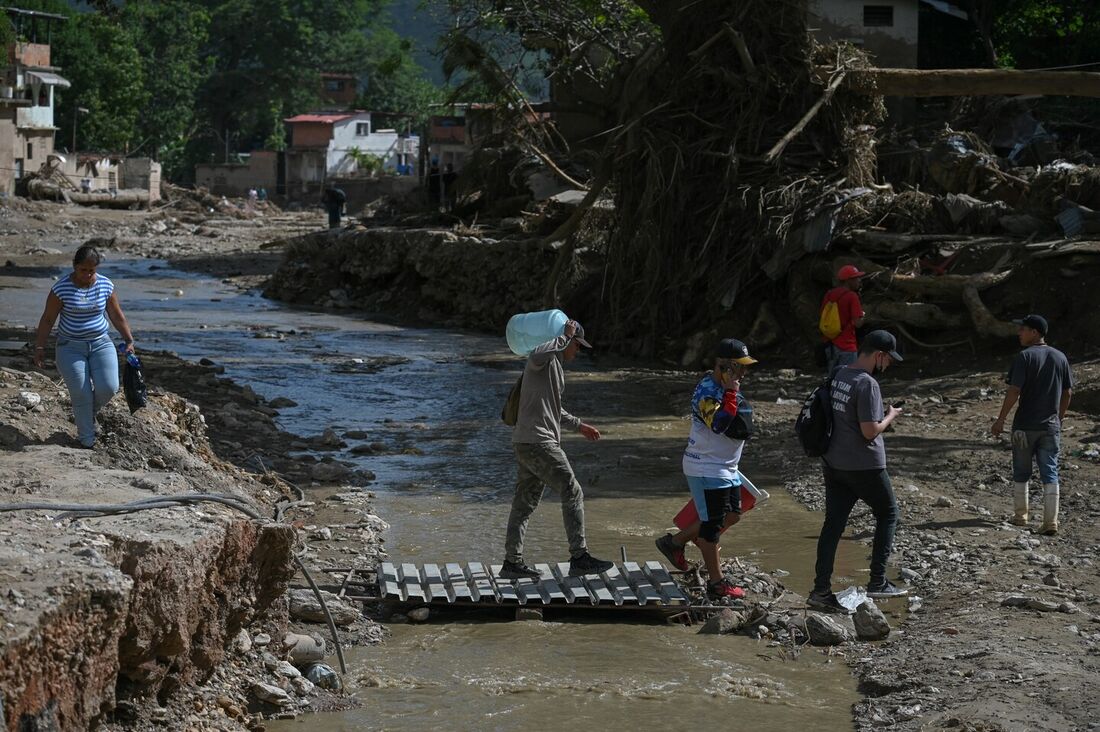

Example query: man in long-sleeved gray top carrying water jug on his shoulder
[499,320,615,579]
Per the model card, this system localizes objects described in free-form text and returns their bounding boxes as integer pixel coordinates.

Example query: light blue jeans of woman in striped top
[56,334,119,447]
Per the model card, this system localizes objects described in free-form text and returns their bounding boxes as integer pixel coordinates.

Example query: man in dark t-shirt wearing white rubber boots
[991,315,1074,535]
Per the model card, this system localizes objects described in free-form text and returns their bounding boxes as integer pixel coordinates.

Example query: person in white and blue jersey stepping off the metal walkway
[657,338,757,598]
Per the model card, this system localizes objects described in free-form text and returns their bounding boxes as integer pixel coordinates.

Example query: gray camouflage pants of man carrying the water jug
[504,443,587,562]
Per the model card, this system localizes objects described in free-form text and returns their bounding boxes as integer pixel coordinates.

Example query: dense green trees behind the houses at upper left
[3,0,468,181]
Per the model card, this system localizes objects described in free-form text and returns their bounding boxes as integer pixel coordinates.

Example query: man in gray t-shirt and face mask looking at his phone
[807,330,908,613]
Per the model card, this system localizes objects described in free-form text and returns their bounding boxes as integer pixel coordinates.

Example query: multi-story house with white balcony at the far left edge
[0,8,69,194]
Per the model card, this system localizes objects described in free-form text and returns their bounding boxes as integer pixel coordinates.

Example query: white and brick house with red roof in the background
[285,111,419,195]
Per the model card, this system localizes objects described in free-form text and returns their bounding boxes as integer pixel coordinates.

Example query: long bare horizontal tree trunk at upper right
[836,68,1100,97]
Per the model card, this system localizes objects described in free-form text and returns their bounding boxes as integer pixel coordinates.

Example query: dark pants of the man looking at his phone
[814,466,898,592]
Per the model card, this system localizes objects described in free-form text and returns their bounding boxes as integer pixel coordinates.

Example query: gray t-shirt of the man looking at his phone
[824,367,887,470]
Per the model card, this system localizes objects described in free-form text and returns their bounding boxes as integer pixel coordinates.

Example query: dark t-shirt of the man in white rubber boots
[1005,346,1074,434]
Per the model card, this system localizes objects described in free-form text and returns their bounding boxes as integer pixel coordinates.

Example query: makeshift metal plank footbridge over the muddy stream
[378,561,691,610]
